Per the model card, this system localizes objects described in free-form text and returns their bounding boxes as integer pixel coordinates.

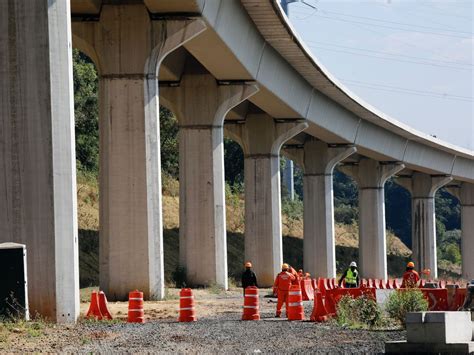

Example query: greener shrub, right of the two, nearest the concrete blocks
[385,288,428,324]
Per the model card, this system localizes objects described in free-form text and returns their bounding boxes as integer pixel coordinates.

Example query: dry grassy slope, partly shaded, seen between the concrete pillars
[78,177,460,287]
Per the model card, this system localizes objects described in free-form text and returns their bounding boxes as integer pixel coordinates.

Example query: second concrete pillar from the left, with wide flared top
[73,4,205,300]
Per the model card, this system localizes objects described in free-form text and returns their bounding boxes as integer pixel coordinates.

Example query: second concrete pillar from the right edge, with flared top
[396,172,452,279]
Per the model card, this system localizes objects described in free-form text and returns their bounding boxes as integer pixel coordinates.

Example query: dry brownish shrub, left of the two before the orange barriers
[336,295,383,328]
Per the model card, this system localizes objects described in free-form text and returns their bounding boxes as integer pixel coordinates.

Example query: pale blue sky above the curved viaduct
[289,0,474,150]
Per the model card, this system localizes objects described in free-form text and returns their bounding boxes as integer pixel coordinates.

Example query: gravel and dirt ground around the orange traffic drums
[0,289,405,354]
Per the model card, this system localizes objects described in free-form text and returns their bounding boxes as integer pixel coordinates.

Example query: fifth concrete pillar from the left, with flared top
[286,137,357,278]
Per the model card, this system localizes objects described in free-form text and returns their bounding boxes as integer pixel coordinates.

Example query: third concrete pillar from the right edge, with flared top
[341,159,405,280]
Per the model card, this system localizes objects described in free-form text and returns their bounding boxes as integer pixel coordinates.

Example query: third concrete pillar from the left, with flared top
[163,69,258,289]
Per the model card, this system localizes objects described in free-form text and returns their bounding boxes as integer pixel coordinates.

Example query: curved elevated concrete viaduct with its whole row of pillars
[0,0,474,322]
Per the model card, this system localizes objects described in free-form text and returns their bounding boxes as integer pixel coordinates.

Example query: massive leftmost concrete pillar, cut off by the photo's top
[0,0,79,323]
